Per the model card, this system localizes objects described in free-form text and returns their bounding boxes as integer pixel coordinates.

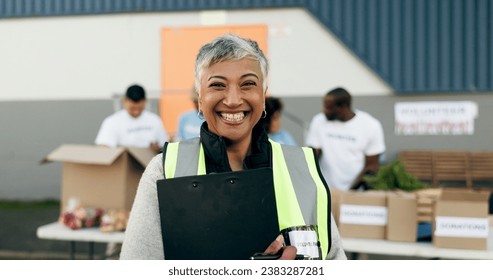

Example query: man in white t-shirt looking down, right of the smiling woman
[306,88,385,191]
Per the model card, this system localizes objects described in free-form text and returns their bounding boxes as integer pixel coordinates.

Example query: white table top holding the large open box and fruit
[36,222,125,243]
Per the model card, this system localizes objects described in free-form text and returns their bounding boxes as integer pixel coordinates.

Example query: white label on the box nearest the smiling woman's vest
[339,204,387,226]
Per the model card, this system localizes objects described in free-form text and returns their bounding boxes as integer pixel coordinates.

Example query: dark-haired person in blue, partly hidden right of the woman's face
[261,96,298,146]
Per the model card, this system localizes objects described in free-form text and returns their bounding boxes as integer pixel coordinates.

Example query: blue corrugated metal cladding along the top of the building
[0,0,493,93]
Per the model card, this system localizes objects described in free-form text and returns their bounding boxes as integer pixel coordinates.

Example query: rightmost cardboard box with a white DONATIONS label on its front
[433,189,489,250]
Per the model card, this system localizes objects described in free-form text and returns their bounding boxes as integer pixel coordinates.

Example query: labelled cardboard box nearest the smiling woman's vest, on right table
[339,191,387,239]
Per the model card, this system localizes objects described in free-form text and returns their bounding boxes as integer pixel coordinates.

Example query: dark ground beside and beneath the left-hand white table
[0,203,106,260]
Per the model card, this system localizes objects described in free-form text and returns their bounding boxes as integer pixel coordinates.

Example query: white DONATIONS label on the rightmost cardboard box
[435,216,489,238]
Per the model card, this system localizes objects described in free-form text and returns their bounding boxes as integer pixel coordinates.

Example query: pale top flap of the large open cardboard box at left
[41,144,125,165]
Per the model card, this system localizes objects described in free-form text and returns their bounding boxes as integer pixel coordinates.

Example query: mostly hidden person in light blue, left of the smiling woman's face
[174,89,204,141]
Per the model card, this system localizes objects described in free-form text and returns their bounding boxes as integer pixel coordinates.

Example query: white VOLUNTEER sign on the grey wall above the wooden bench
[394,101,478,135]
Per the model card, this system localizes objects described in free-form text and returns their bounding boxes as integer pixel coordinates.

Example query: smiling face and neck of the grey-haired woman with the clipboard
[199,58,265,170]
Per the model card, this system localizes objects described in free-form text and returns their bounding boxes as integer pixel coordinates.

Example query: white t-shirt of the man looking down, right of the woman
[306,110,385,191]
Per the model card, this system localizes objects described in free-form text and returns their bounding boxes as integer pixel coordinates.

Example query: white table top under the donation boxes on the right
[342,227,493,260]
